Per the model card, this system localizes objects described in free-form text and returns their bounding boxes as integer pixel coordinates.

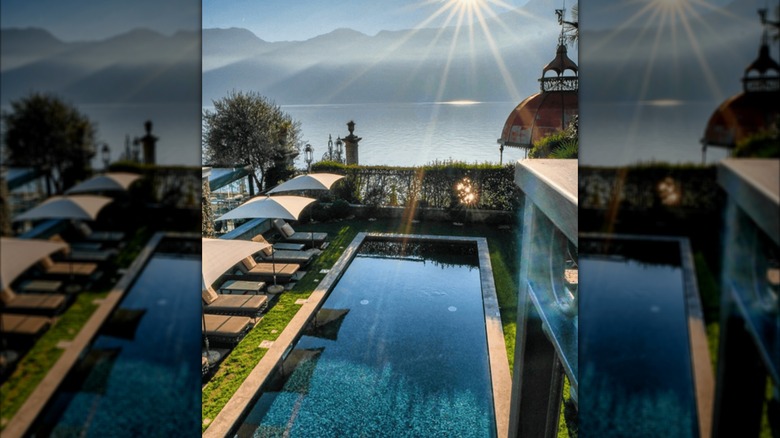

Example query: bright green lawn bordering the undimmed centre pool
[202,216,532,430]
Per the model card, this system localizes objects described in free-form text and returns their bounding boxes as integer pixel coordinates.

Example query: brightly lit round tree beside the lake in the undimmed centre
[202,91,300,190]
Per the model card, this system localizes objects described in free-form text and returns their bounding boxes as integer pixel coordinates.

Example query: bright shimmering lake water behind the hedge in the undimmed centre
[205,102,525,168]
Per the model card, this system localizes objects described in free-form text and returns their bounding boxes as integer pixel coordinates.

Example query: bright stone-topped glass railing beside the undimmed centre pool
[509,159,579,437]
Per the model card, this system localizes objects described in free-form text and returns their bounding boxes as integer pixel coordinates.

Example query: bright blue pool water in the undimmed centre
[237,242,495,437]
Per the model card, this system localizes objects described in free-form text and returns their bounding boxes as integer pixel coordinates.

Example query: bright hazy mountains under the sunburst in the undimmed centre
[202,0,577,105]
